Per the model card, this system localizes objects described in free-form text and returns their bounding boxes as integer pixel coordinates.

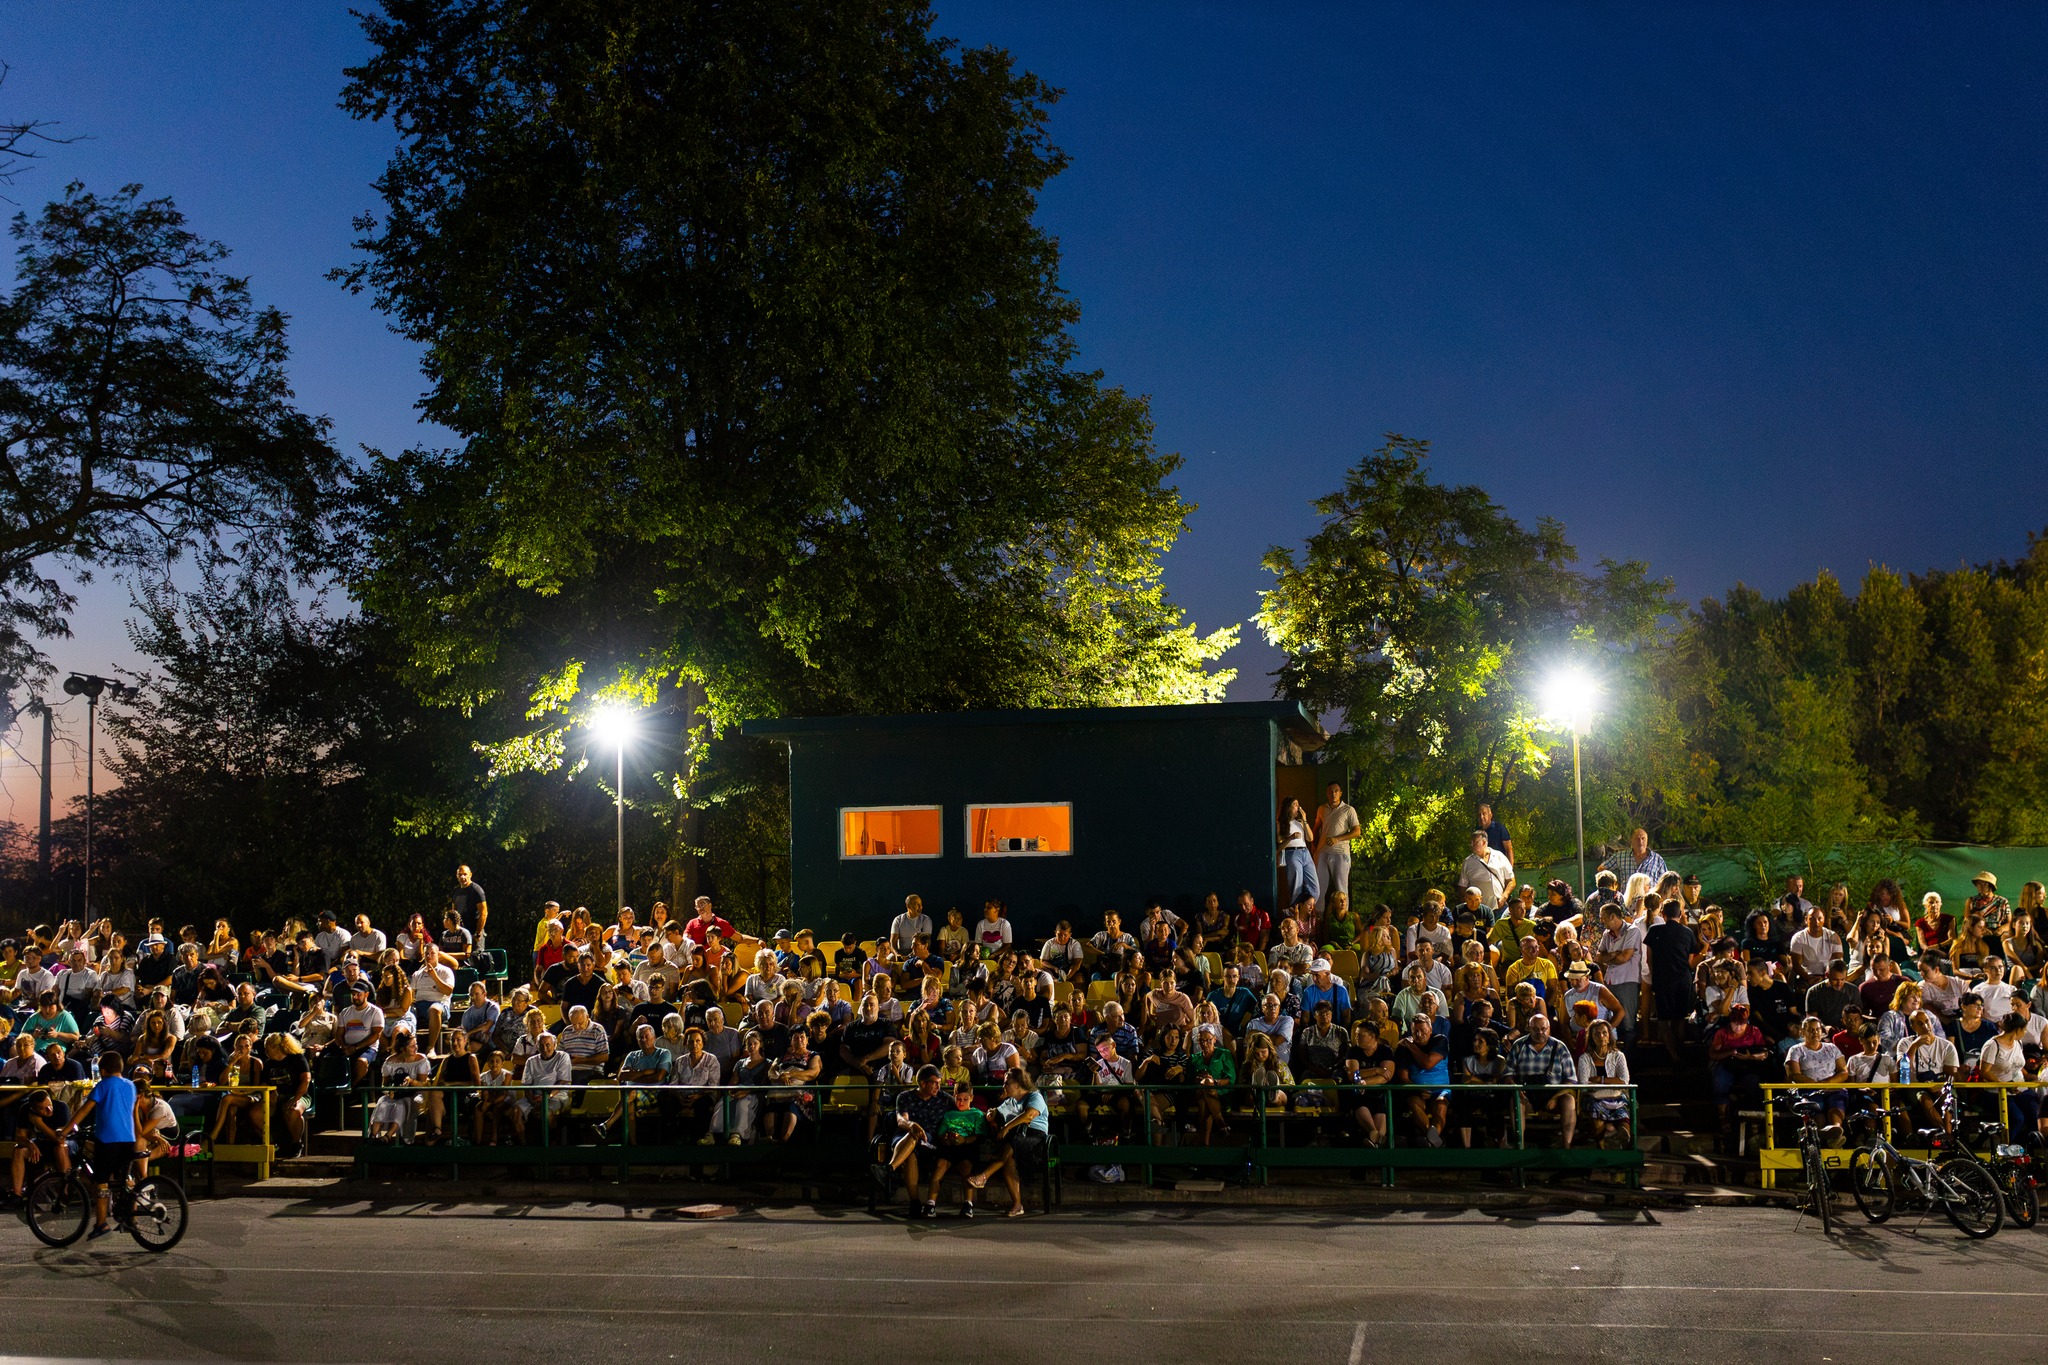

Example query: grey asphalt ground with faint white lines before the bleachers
[0,1199,2048,1365]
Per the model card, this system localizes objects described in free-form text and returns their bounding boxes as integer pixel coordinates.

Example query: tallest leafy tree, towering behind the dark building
[344,0,1231,806]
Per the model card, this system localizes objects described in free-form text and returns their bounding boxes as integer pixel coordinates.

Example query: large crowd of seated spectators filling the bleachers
[0,822,2048,1212]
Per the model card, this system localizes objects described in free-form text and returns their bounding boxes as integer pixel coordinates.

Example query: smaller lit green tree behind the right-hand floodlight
[1257,434,1688,896]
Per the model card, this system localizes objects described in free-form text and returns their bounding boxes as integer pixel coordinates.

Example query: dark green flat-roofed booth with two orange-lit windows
[741,702,1323,941]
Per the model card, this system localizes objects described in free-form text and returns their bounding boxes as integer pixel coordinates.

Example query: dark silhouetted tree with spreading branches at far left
[0,184,342,687]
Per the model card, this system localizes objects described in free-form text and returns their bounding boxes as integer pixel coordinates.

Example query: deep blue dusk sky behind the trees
[0,0,2048,810]
